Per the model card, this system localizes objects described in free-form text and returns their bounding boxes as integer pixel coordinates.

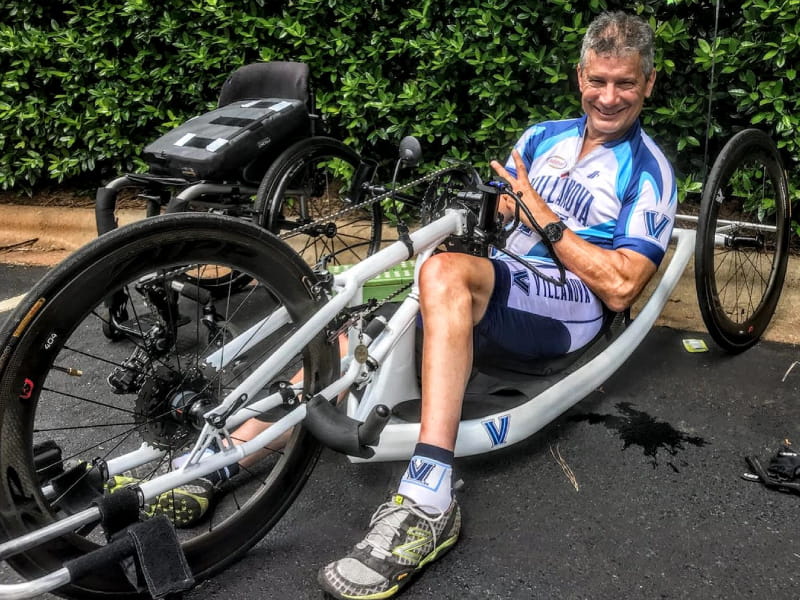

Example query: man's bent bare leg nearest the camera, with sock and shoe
[317,253,494,598]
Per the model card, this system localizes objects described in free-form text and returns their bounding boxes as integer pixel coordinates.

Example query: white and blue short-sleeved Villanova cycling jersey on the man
[496,115,677,266]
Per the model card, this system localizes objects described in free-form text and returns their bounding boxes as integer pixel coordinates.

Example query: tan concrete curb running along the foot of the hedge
[0,188,800,344]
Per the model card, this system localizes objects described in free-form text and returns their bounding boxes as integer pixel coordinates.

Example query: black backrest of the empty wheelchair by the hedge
[217,61,315,115]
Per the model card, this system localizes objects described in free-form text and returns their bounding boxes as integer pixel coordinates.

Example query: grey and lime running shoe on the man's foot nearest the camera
[317,494,461,600]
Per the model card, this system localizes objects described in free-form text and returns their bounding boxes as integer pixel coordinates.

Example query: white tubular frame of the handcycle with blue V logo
[141,210,695,497]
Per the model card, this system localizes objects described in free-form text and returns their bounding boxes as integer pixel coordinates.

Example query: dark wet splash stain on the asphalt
[570,402,708,472]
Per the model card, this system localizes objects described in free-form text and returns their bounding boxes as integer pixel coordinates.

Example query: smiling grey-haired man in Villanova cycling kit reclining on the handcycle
[318,12,676,599]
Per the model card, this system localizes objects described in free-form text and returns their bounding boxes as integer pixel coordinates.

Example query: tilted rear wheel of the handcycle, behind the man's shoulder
[695,129,790,353]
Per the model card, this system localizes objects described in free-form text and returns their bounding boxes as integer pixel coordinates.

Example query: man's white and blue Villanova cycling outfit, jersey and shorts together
[474,115,677,365]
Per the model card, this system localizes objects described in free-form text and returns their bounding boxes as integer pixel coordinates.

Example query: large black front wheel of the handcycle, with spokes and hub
[0,214,339,598]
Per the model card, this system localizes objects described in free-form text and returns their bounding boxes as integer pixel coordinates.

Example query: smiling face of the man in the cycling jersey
[578,50,656,142]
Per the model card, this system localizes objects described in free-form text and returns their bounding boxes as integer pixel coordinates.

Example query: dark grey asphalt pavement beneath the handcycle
[0,265,800,600]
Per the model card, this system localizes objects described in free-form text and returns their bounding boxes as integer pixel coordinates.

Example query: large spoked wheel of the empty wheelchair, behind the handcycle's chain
[255,136,382,265]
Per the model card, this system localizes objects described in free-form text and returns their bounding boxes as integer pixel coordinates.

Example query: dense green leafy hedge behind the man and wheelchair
[0,0,800,216]
